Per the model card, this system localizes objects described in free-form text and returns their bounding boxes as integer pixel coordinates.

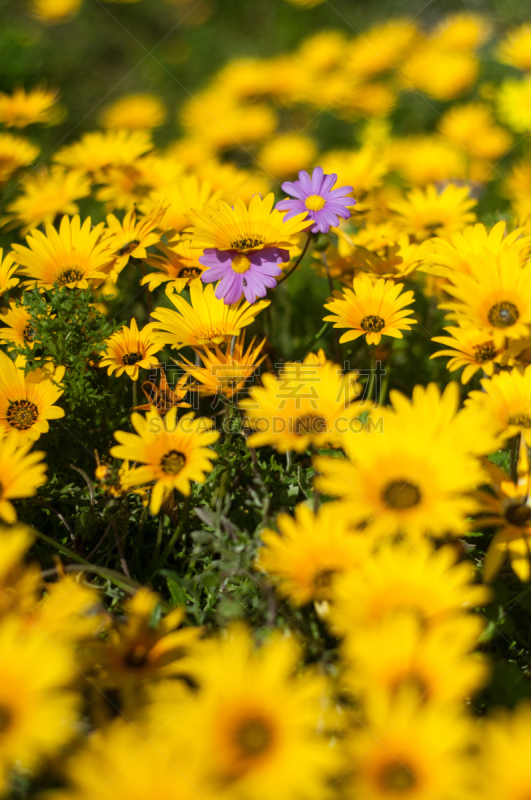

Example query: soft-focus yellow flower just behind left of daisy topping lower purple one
[142,175,219,233]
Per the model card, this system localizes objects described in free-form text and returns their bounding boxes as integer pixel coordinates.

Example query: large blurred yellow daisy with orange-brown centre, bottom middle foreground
[148,625,338,800]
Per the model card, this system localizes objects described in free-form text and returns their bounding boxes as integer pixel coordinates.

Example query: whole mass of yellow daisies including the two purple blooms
[5,7,531,800]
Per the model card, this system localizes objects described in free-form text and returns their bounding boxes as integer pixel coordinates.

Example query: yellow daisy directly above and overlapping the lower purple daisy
[188,194,308,253]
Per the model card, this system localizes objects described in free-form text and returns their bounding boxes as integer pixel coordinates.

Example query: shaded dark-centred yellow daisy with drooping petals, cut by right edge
[474,434,531,581]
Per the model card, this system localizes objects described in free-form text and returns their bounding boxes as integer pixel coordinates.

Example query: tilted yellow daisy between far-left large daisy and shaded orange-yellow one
[103,207,165,280]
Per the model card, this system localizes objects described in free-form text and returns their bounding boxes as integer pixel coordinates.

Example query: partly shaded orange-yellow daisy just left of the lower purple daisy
[140,239,206,294]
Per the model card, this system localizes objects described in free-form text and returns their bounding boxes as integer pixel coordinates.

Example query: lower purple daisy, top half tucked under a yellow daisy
[199,247,289,306]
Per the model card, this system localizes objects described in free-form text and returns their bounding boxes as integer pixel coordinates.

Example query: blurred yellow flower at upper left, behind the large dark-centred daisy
[2,166,90,236]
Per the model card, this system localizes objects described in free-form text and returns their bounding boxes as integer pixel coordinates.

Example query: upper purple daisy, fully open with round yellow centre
[276,167,356,233]
